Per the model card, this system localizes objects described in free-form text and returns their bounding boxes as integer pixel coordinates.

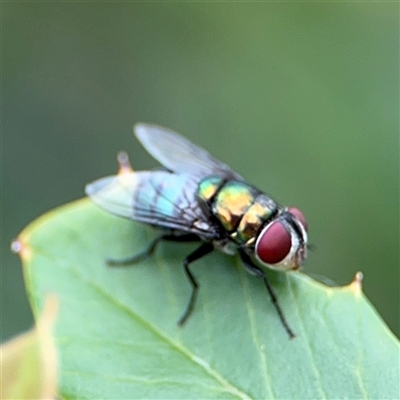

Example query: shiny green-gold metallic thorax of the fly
[197,176,278,246]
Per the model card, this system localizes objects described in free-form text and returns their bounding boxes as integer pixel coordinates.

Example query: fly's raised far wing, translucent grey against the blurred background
[134,123,243,180]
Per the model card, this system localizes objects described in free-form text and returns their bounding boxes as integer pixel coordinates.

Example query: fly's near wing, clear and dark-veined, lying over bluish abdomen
[85,171,216,239]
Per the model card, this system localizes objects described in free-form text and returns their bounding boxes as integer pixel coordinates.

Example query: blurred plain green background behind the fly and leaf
[1,2,400,339]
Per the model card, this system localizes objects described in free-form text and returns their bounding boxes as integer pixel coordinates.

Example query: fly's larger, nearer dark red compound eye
[255,221,292,264]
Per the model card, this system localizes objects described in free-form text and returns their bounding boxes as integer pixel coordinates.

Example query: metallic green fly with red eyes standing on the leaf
[86,123,307,338]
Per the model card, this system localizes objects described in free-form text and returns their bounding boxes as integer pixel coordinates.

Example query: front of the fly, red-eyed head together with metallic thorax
[198,177,307,270]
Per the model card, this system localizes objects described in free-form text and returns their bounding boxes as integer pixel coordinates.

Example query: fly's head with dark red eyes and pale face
[255,207,307,271]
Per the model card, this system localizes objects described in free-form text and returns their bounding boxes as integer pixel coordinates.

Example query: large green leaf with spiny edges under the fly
[14,200,400,399]
